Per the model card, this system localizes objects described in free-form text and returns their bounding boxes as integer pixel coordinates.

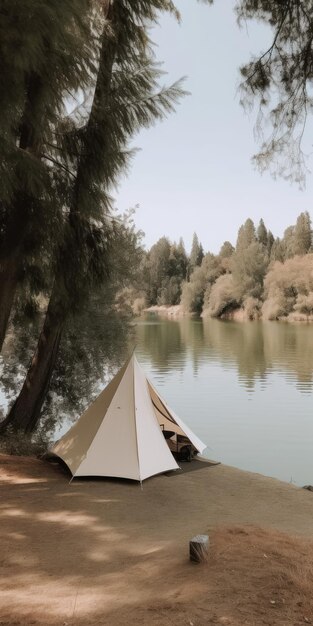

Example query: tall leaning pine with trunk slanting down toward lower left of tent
[2,0,183,432]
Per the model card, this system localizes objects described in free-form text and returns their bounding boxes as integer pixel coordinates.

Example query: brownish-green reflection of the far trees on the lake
[137,315,313,392]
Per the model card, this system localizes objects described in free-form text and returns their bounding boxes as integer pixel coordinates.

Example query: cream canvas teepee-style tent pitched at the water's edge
[50,354,206,482]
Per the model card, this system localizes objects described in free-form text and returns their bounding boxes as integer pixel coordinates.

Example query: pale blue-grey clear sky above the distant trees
[115,0,313,253]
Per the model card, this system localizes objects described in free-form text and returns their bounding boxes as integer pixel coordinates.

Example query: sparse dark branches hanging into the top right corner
[236,0,313,184]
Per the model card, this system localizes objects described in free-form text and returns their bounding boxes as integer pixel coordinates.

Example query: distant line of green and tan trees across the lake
[128,212,313,319]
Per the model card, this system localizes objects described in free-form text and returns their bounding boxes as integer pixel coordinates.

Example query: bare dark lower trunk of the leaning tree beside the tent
[0,298,64,433]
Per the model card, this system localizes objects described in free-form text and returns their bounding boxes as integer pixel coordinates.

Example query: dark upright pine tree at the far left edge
[0,0,96,348]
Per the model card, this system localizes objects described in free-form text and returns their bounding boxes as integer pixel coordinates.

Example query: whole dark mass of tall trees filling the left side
[0,0,184,433]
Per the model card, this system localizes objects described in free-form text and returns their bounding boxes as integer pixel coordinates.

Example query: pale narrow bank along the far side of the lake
[143,304,313,323]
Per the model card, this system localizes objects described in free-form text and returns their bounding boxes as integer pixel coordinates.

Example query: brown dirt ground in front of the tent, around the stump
[0,455,313,626]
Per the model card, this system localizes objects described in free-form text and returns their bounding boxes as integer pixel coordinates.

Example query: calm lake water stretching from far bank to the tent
[136,314,313,485]
